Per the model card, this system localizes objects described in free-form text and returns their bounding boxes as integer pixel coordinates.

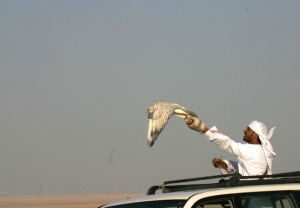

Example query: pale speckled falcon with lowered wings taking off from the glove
[147,101,197,147]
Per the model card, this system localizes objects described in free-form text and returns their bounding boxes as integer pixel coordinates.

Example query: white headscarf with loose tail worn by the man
[248,121,276,171]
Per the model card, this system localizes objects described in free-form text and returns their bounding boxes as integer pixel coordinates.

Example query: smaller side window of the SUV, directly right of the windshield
[193,198,234,208]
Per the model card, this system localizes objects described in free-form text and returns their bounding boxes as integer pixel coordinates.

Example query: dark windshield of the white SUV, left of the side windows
[104,200,186,208]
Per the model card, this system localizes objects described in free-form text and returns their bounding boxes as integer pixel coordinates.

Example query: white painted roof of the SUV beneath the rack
[103,183,300,208]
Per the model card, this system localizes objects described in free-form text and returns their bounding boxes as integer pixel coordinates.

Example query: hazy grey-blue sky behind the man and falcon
[0,0,300,195]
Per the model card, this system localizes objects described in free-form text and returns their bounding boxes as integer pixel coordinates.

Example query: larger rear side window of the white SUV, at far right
[240,193,296,208]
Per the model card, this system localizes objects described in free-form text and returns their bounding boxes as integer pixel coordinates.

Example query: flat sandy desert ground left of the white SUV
[0,194,141,208]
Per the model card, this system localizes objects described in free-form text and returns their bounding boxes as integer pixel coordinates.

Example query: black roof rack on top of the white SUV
[147,171,300,195]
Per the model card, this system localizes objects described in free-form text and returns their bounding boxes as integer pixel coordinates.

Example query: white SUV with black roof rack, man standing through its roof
[101,172,300,208]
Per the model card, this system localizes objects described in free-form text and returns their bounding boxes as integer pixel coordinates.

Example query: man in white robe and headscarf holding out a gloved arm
[186,118,276,176]
